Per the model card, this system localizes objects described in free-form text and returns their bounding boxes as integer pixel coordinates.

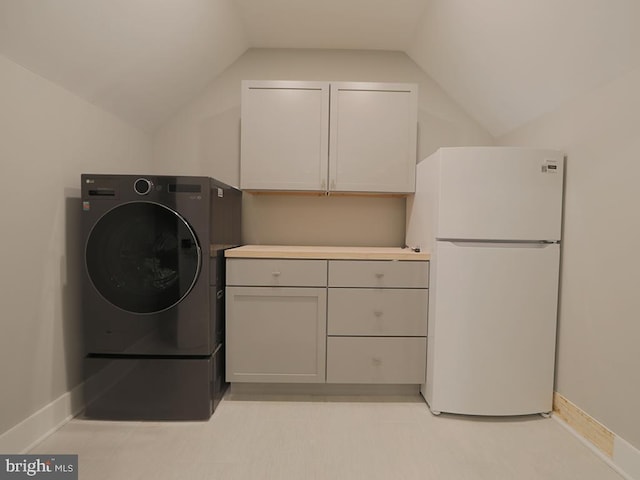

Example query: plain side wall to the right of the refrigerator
[499,63,640,448]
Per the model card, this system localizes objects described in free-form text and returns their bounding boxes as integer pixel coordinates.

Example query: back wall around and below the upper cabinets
[153,49,493,246]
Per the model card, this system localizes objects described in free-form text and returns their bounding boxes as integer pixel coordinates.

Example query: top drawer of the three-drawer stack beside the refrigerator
[329,260,429,288]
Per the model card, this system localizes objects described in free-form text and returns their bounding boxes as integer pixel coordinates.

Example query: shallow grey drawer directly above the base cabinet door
[227,258,327,287]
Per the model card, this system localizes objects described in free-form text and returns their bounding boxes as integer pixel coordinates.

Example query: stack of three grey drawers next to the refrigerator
[327,260,429,384]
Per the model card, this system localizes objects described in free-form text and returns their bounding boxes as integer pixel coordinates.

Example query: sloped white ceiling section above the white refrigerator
[408,0,640,137]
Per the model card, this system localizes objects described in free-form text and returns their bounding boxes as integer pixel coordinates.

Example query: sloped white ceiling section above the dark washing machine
[0,0,248,131]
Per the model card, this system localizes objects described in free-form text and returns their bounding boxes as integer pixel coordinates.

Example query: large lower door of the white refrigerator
[423,242,560,415]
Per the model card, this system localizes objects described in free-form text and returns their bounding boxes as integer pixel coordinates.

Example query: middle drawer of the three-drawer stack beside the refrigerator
[327,288,429,337]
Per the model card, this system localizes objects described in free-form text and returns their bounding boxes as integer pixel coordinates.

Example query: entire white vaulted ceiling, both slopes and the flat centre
[0,0,640,136]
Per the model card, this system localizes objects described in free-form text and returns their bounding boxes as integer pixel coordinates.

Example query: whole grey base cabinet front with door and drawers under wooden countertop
[226,255,429,384]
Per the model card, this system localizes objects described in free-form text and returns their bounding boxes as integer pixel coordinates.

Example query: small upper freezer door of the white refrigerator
[438,147,564,240]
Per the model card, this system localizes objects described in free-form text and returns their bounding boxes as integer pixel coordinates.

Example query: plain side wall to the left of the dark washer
[0,56,151,440]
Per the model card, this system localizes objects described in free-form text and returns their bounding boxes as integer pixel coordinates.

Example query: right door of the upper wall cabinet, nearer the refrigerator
[329,82,418,193]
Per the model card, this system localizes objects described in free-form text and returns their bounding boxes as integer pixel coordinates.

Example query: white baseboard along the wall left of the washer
[0,384,84,454]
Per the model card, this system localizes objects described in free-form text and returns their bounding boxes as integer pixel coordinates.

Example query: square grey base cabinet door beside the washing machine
[226,287,327,383]
